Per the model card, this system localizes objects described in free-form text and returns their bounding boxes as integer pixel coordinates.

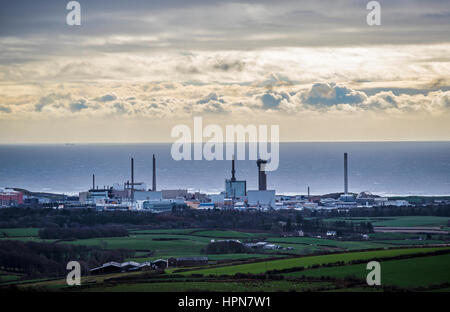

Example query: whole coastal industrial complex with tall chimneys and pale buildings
[0,153,432,213]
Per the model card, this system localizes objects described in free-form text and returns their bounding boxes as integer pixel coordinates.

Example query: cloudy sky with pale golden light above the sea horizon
[0,0,450,144]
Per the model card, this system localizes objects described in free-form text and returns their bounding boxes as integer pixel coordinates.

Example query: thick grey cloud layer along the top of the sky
[0,0,450,58]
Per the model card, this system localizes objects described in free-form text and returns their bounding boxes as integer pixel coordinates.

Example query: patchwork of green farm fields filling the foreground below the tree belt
[0,216,450,292]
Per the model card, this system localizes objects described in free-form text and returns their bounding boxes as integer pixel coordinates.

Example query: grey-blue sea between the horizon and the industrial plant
[0,142,450,196]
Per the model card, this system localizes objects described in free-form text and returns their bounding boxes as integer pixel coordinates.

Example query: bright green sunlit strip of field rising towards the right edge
[183,247,450,275]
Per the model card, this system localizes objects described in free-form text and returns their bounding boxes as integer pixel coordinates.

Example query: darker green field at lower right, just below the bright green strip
[284,254,450,288]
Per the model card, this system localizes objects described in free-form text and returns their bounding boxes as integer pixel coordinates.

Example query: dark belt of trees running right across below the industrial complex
[0,206,450,234]
